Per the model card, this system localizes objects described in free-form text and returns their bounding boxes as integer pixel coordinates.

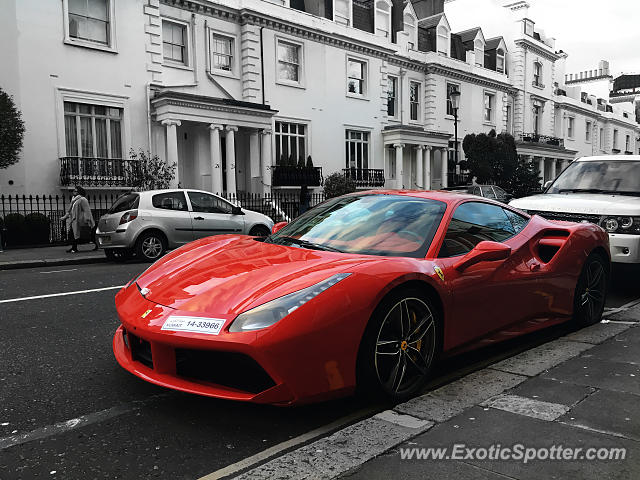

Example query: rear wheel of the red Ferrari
[573,253,610,327]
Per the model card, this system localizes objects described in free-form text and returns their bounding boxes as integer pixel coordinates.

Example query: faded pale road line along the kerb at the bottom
[199,408,376,480]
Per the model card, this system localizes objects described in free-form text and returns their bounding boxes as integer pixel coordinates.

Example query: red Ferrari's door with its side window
[437,201,538,344]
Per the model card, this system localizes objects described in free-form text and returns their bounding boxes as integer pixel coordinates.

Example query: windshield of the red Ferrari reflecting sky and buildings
[267,194,447,258]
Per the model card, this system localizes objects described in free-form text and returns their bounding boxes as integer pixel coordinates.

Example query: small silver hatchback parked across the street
[96,189,273,261]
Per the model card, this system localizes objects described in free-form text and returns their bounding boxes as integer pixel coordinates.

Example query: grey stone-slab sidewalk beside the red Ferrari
[234,305,640,480]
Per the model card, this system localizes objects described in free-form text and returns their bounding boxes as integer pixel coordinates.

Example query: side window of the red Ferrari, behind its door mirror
[438,202,516,258]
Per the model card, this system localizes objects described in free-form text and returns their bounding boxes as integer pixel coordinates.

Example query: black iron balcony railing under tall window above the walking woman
[60,157,142,188]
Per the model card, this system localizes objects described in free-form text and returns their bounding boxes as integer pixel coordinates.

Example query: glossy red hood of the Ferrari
[136,235,375,314]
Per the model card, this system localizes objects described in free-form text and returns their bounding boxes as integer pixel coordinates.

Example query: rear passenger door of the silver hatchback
[151,190,193,247]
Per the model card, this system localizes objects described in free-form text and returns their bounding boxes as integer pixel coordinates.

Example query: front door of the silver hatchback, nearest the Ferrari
[188,191,244,239]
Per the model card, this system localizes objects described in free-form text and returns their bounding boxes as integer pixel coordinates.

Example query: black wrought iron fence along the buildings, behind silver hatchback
[0,191,325,247]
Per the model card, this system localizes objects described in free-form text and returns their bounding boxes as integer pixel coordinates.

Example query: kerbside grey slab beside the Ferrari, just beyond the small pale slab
[491,339,593,377]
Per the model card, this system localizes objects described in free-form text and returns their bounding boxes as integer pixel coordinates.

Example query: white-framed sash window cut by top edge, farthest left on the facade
[66,0,112,46]
